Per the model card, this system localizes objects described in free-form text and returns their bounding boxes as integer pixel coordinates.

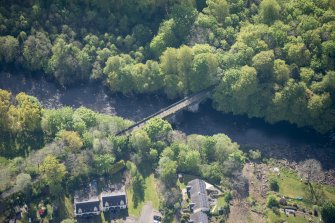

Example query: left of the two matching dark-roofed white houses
[74,182,100,217]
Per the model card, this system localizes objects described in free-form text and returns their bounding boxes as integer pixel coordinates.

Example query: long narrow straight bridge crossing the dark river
[116,87,214,136]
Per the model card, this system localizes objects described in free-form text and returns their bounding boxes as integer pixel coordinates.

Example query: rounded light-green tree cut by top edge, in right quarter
[259,0,281,25]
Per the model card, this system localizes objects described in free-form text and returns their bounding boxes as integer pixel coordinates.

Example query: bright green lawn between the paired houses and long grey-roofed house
[127,174,159,217]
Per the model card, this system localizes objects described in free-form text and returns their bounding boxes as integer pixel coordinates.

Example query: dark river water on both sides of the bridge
[0,71,335,167]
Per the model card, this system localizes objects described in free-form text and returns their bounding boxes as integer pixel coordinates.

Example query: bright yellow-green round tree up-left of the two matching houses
[39,155,67,185]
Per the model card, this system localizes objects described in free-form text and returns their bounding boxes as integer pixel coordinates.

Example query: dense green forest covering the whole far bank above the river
[0,0,335,133]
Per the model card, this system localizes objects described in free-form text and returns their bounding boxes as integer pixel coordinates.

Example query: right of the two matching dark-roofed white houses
[100,185,127,211]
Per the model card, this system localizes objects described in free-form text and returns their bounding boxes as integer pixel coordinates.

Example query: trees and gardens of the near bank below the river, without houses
[0,90,335,223]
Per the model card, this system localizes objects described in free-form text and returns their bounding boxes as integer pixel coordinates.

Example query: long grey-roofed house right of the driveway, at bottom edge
[186,179,210,223]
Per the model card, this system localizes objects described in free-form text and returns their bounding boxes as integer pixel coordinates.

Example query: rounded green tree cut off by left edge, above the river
[0,36,19,63]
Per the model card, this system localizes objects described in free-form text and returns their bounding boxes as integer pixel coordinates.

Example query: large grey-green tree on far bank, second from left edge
[22,32,52,70]
